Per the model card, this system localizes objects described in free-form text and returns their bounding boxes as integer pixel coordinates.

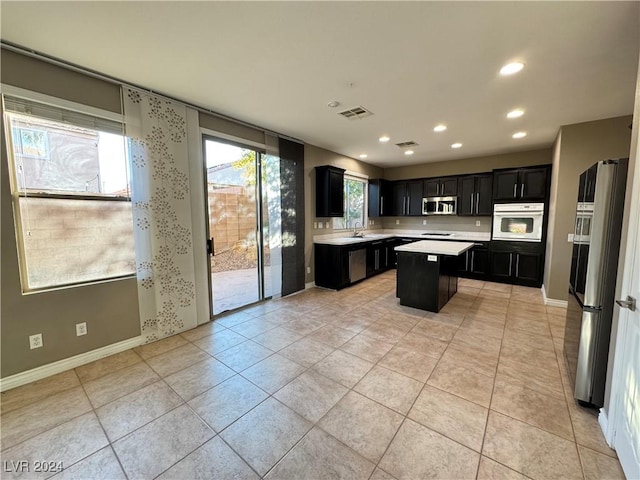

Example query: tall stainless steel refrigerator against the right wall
[564,158,628,407]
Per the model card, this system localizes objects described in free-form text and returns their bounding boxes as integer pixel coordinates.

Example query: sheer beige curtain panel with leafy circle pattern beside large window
[123,87,197,343]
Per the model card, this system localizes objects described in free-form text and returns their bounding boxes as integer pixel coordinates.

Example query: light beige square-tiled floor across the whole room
[1,272,623,480]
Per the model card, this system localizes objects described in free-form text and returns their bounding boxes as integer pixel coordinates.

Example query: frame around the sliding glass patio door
[202,133,271,320]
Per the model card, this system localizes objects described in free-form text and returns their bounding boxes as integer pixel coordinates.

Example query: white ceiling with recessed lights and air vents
[0,0,640,167]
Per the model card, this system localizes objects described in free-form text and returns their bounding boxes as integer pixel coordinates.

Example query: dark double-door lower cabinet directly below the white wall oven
[491,244,544,287]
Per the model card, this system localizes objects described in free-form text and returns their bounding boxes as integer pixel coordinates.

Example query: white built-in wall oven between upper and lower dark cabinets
[491,203,544,242]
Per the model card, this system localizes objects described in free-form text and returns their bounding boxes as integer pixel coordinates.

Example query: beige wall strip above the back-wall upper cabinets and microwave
[383,148,551,180]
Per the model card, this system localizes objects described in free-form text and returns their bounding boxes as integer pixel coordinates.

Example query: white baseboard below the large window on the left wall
[0,336,142,392]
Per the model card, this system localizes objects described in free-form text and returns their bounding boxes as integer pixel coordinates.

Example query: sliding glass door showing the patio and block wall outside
[204,138,270,315]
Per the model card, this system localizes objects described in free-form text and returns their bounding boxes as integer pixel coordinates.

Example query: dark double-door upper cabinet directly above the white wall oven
[493,167,549,202]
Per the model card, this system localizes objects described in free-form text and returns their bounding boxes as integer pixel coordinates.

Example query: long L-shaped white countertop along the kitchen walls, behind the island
[313,229,491,245]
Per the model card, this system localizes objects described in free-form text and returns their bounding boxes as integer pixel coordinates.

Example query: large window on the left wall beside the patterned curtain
[3,95,135,291]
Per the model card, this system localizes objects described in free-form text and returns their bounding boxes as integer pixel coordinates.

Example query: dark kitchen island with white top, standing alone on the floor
[395,240,473,312]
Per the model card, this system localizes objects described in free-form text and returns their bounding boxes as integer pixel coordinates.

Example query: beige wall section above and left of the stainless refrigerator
[544,115,632,300]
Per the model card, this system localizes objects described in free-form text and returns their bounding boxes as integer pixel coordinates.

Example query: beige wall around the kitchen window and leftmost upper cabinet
[304,144,382,283]
